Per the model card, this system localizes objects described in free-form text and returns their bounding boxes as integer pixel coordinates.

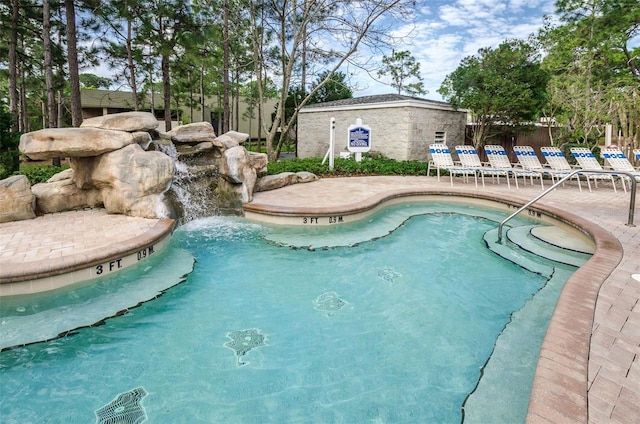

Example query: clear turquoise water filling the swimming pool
[0,204,575,423]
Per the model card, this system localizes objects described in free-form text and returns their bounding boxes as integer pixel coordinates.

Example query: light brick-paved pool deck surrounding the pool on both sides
[0,177,640,424]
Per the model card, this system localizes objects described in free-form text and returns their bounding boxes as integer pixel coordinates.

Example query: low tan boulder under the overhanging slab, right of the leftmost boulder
[31,169,102,213]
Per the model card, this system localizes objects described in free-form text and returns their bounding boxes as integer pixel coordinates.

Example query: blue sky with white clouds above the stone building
[358,0,555,100]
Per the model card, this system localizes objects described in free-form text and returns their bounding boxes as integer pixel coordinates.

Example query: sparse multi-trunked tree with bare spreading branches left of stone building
[248,0,413,160]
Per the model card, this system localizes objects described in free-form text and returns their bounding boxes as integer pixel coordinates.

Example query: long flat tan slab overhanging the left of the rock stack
[19,128,135,160]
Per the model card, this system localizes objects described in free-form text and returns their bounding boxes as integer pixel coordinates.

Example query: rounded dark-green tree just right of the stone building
[438,40,548,148]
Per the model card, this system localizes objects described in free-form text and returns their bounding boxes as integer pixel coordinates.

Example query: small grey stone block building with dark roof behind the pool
[298,94,467,161]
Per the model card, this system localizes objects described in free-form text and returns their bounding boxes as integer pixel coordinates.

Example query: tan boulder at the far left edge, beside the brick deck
[0,175,36,222]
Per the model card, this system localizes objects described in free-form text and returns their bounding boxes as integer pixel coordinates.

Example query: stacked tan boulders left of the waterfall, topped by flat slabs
[20,112,175,218]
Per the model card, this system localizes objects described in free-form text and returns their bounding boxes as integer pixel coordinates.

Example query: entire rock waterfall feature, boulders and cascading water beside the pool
[11,112,267,221]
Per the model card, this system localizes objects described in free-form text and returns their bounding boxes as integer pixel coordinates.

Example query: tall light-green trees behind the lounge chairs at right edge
[539,0,640,150]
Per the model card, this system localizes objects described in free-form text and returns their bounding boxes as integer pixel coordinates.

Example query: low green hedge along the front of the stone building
[266,156,427,177]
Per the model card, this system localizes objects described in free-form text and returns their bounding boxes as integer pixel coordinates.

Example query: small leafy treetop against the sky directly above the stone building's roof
[378,50,427,96]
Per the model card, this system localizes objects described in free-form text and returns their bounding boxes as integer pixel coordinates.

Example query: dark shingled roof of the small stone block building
[301,94,466,112]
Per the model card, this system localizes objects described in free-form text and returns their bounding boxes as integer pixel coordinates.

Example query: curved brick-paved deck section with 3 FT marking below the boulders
[0,209,175,296]
